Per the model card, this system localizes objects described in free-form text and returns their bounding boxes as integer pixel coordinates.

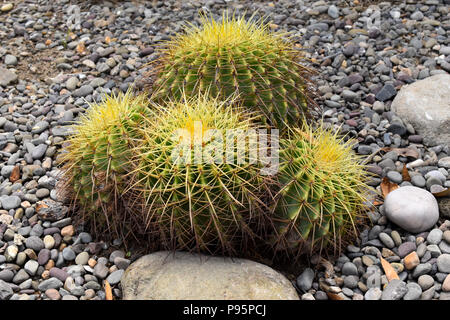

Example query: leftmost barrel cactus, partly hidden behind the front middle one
[60,91,149,236]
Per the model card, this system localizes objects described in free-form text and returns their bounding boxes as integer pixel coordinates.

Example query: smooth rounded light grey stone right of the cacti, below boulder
[384,186,439,233]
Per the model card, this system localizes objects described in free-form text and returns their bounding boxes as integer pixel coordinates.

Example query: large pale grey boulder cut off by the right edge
[391,74,450,145]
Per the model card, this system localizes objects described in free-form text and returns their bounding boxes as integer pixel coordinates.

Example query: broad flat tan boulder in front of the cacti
[121,251,299,300]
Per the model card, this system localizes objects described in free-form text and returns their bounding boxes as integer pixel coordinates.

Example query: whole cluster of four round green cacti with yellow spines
[58,15,367,254]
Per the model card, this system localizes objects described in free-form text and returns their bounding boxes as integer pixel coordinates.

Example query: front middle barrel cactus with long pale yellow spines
[128,95,267,254]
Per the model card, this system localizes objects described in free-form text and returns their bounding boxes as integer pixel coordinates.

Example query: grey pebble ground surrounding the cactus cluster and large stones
[0,0,450,300]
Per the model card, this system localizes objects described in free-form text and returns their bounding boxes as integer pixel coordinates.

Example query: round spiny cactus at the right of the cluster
[275,125,369,254]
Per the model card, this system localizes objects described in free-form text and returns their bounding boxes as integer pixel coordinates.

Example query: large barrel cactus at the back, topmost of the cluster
[149,14,315,129]
